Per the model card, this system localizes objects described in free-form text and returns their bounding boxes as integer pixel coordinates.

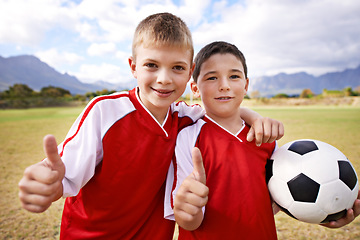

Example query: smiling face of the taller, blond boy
[129,45,193,117]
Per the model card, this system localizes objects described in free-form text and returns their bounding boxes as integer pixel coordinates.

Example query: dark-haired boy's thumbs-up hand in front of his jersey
[174,147,209,231]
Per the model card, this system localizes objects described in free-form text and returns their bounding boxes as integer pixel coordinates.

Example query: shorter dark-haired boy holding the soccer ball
[164,42,360,240]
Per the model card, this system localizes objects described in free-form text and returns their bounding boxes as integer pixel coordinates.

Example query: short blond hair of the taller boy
[132,13,194,61]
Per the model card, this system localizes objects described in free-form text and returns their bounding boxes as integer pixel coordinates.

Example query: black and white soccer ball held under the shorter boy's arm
[266,139,359,223]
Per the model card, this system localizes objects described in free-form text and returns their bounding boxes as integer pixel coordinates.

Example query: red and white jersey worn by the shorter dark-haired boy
[164,116,277,240]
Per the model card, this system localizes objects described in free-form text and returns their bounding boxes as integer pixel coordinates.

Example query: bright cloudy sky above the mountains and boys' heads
[0,0,360,83]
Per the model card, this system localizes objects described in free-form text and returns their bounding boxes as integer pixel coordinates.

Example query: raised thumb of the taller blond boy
[44,135,65,175]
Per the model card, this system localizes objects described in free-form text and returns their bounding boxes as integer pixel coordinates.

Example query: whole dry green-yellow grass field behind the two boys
[0,106,360,240]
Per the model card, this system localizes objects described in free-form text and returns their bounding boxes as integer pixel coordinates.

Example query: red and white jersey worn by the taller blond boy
[58,88,204,239]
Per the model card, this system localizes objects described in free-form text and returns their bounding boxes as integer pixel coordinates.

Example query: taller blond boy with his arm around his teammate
[19,13,282,239]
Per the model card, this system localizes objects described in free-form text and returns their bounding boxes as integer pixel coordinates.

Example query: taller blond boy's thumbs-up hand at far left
[19,135,65,213]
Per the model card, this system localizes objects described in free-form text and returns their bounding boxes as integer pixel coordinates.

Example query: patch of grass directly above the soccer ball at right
[253,107,360,173]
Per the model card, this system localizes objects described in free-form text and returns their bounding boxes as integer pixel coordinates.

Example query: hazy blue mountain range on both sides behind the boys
[0,55,360,97]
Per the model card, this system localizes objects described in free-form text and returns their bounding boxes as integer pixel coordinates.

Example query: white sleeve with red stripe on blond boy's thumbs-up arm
[58,92,136,197]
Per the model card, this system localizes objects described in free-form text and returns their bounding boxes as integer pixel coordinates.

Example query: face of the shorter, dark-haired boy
[191,53,249,123]
